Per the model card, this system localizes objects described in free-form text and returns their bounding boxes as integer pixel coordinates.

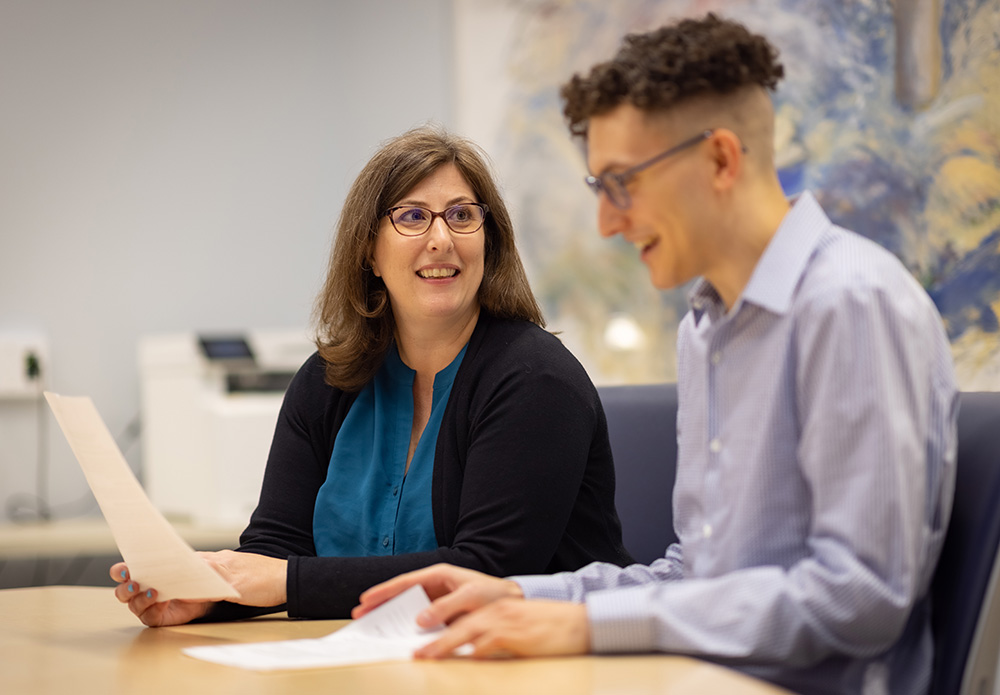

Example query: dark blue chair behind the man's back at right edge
[930,392,1000,695]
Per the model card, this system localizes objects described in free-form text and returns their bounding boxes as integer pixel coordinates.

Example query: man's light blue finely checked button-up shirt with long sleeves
[517,193,957,693]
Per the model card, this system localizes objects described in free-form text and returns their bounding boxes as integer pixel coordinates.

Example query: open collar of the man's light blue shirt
[688,191,831,323]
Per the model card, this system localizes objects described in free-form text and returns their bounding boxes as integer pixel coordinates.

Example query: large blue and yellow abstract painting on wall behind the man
[456,0,1000,390]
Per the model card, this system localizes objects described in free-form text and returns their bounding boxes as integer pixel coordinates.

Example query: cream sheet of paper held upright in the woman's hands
[45,391,239,601]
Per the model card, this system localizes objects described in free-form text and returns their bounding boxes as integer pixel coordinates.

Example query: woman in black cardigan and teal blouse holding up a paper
[111,128,630,625]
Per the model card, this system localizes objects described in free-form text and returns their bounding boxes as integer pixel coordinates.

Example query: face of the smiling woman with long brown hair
[372,164,486,334]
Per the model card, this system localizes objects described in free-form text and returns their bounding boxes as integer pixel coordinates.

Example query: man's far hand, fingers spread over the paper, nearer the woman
[351,565,524,627]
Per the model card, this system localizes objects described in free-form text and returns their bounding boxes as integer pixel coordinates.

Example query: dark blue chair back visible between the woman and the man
[598,384,677,565]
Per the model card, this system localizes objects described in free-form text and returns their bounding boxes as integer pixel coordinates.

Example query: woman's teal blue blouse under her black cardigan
[313,344,467,557]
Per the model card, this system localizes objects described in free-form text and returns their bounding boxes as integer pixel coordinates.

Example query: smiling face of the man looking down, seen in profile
[587,104,712,289]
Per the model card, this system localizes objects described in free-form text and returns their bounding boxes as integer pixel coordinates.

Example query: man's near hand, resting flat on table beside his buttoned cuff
[414,599,590,659]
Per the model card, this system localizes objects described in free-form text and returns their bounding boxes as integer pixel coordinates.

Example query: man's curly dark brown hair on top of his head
[560,12,785,136]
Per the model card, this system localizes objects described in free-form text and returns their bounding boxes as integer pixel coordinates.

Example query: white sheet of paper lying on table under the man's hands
[184,586,456,671]
